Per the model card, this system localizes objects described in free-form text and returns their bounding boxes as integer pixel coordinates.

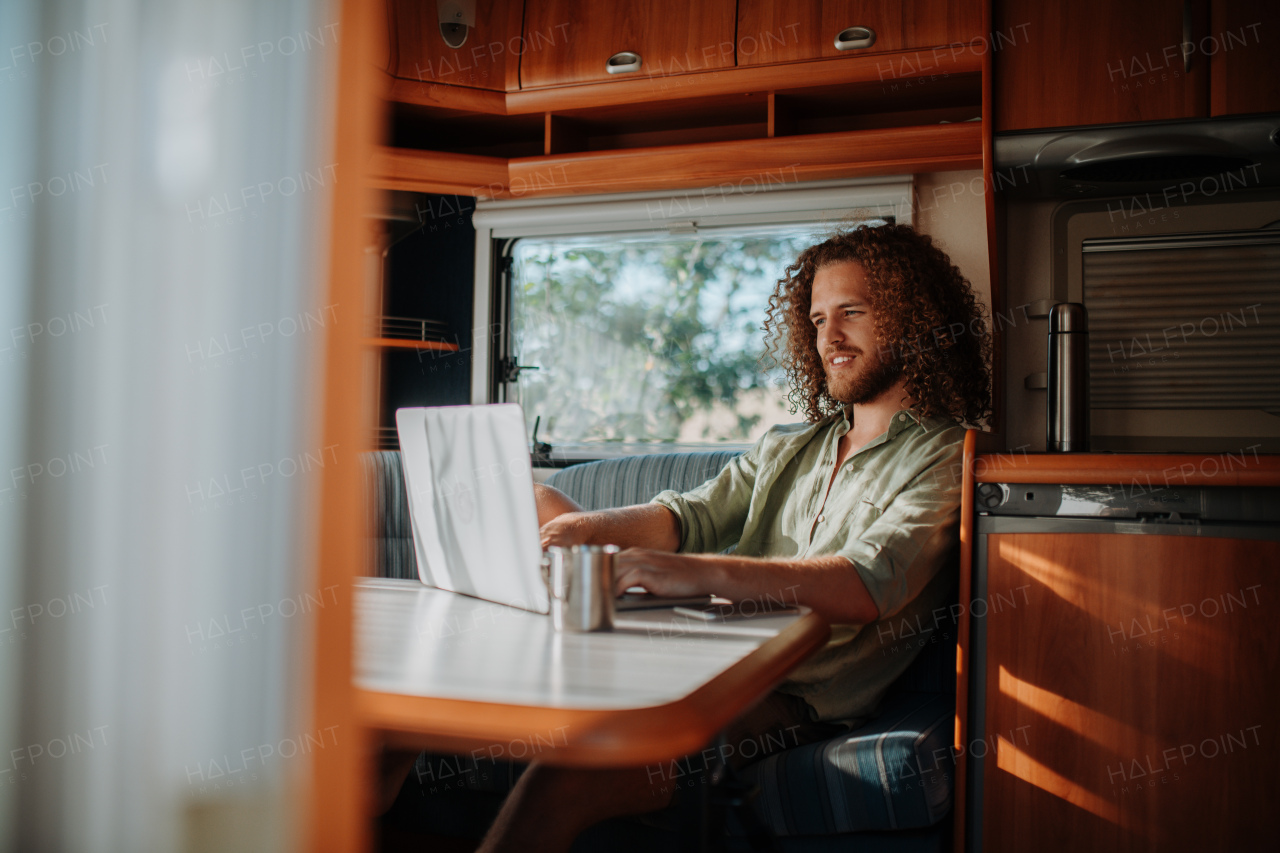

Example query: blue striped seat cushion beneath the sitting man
[742,693,955,836]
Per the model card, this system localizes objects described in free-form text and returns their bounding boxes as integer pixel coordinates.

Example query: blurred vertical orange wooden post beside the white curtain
[307,3,385,853]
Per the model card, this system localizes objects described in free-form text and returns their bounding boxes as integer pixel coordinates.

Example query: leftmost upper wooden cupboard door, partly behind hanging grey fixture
[388,0,527,92]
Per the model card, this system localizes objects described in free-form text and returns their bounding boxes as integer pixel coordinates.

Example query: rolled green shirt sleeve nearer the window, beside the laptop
[650,433,768,553]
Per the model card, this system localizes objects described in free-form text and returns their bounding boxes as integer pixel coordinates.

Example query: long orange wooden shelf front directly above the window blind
[503,123,982,197]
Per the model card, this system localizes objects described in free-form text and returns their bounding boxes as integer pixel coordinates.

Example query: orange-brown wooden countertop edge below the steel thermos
[974,448,1280,491]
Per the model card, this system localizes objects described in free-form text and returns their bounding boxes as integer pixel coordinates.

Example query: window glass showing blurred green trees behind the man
[511,227,822,452]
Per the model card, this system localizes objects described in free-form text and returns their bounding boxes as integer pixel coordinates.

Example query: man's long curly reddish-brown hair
[764,224,991,425]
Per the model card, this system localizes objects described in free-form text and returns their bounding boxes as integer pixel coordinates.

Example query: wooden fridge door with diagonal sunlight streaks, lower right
[974,534,1280,853]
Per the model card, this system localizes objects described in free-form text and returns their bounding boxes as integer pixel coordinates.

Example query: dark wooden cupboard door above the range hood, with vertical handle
[992,0,1208,131]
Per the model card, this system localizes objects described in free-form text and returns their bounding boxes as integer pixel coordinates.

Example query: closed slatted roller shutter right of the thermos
[1083,229,1280,414]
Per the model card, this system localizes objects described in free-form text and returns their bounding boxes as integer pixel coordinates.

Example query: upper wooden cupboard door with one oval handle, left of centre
[520,0,736,88]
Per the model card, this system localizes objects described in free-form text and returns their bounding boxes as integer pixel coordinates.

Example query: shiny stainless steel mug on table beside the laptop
[543,546,618,633]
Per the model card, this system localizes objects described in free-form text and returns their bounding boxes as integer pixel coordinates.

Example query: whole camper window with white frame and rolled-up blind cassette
[471,175,913,461]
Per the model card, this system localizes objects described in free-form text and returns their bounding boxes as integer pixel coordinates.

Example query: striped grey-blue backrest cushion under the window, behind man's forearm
[547,451,740,510]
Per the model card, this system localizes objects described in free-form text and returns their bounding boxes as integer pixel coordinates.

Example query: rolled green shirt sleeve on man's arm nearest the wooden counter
[836,433,964,619]
